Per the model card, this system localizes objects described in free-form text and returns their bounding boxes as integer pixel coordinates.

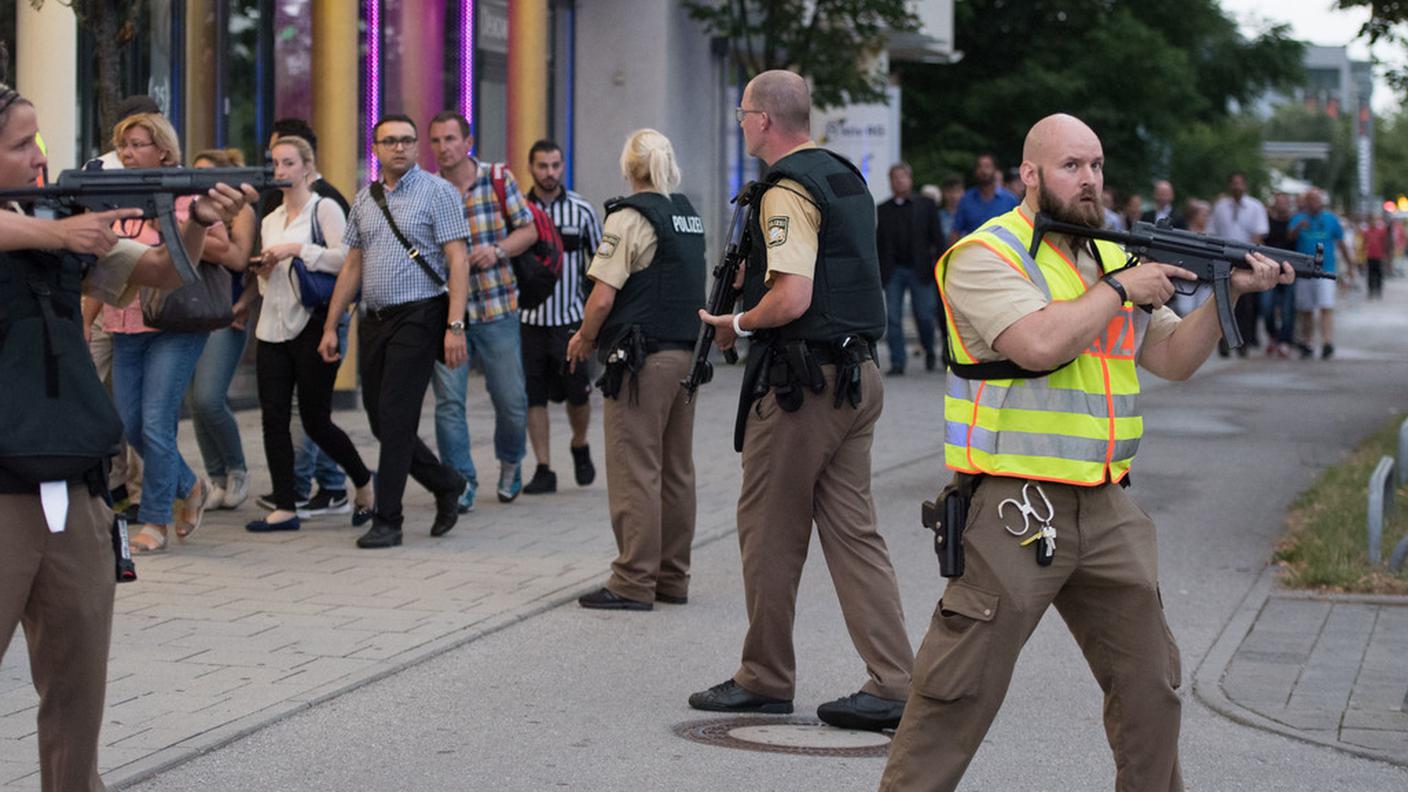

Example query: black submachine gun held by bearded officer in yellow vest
[1028,213,1335,349]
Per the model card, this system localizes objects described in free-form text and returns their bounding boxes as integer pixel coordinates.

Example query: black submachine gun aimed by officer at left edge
[0,168,289,285]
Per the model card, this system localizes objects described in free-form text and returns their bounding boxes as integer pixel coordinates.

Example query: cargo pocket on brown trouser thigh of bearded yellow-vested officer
[914,581,998,700]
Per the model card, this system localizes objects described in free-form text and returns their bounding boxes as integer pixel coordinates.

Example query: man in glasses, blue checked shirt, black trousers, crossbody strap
[318,114,469,548]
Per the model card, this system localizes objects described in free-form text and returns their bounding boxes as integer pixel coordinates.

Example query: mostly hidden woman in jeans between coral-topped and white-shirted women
[189,148,258,509]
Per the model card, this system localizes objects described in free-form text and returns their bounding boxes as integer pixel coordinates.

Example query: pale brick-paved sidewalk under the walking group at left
[0,364,942,792]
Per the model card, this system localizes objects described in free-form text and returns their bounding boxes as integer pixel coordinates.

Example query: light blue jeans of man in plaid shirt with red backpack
[431,316,528,489]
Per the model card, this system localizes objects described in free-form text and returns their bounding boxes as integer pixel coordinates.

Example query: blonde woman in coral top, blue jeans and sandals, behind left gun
[103,113,235,552]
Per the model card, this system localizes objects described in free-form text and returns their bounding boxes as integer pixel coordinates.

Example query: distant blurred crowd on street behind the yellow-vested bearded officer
[877,154,1408,376]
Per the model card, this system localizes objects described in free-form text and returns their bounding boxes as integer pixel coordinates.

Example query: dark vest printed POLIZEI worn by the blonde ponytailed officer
[598,193,705,362]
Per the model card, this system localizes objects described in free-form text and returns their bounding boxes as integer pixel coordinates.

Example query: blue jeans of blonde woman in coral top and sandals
[113,331,208,526]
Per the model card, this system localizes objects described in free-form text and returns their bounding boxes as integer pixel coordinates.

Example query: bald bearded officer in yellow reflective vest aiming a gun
[880,116,1294,792]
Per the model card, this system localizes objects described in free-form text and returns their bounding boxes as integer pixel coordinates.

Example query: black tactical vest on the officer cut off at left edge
[0,251,122,492]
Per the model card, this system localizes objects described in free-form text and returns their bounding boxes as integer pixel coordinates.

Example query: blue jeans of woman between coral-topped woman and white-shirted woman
[189,327,249,485]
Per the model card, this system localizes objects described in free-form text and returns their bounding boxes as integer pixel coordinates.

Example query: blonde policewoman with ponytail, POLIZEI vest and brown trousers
[567,130,704,610]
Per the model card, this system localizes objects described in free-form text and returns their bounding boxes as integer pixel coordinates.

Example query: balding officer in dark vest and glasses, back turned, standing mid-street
[690,70,914,730]
